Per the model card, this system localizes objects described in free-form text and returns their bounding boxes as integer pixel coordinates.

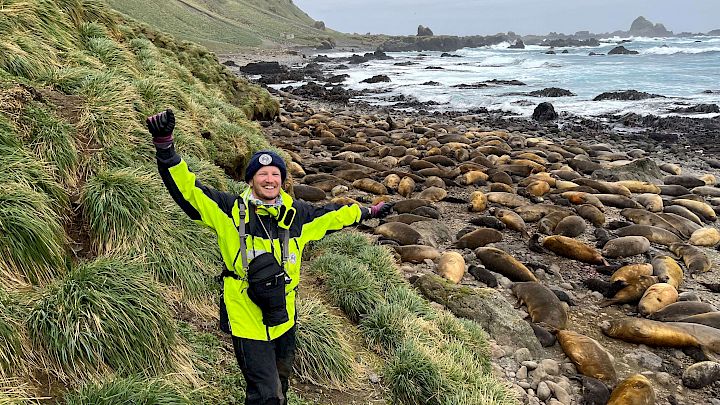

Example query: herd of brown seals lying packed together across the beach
[264,87,720,404]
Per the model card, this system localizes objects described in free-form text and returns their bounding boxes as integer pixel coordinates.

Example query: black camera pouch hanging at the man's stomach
[248,253,290,326]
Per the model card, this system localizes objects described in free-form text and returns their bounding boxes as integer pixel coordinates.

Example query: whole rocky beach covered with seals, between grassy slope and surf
[225,48,720,404]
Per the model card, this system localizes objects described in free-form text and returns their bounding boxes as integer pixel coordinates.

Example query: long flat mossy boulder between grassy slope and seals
[415,274,542,357]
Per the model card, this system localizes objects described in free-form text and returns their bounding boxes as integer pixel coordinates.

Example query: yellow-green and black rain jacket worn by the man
[157,146,367,340]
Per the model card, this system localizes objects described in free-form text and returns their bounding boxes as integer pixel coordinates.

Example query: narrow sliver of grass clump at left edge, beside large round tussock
[0,288,22,378]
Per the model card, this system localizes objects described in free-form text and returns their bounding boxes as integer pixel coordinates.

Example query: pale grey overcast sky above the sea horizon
[294,0,720,35]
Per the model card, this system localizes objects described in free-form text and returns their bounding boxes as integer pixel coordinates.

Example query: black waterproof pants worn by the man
[232,326,297,405]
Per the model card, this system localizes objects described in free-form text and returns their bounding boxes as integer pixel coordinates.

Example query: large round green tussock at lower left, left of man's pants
[27,257,175,379]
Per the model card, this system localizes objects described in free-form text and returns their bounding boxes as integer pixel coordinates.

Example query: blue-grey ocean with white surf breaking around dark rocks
[274,36,720,118]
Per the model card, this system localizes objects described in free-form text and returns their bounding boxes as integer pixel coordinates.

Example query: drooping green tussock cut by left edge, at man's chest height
[0,182,66,284]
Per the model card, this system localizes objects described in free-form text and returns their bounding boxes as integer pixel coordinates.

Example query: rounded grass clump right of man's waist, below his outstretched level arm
[311,254,383,322]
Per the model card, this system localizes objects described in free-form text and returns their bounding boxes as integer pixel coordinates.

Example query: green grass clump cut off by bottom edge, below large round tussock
[64,376,193,405]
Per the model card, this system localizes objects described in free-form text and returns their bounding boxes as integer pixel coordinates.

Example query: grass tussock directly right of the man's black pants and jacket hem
[294,298,356,389]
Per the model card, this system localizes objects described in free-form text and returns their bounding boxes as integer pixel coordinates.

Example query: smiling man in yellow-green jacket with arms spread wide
[147,109,392,405]
